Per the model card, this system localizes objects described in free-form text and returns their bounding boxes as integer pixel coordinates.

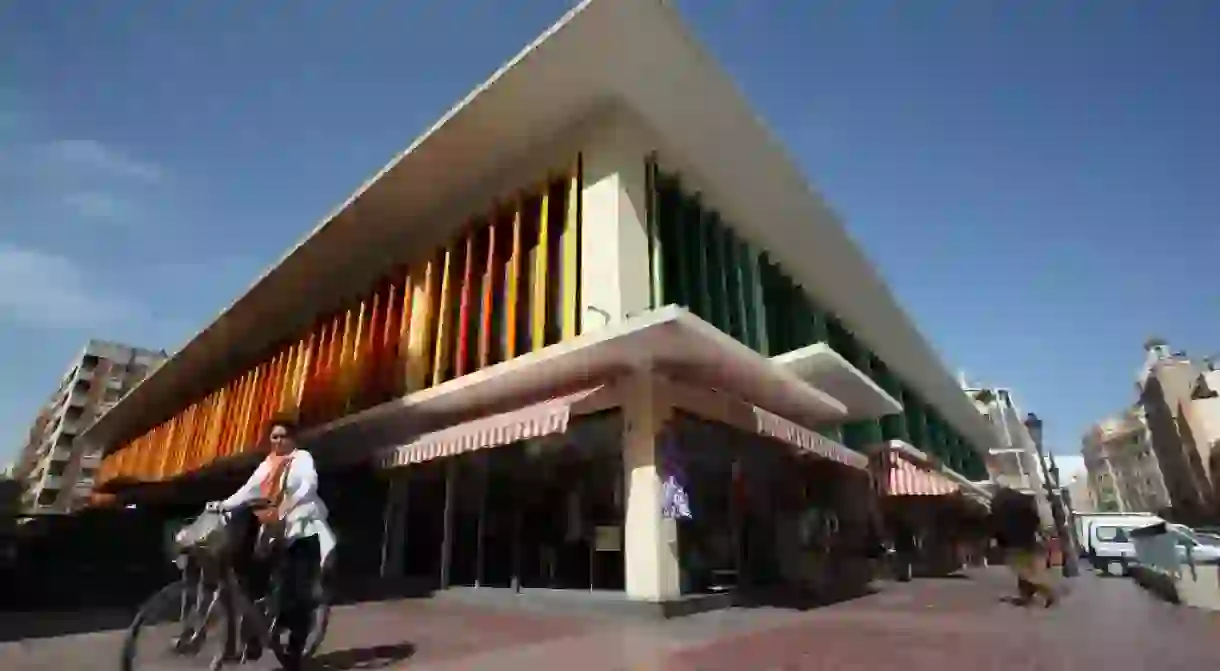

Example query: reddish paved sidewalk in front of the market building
[0,569,1220,671]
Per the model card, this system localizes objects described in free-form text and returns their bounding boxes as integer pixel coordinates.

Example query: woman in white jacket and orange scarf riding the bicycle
[214,417,336,671]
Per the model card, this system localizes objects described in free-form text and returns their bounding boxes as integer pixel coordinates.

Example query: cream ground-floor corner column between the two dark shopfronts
[622,372,681,601]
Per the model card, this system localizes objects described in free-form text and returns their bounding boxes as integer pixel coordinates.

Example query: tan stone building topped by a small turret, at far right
[1137,339,1214,522]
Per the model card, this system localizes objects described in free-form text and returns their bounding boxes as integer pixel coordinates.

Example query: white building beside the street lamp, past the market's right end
[961,379,1052,525]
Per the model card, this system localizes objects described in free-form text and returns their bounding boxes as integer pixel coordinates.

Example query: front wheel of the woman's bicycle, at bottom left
[120,580,235,671]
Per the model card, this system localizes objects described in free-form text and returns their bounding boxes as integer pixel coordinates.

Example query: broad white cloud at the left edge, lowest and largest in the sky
[0,243,145,329]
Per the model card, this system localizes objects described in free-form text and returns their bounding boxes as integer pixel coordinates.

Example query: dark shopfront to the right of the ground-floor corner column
[662,414,870,594]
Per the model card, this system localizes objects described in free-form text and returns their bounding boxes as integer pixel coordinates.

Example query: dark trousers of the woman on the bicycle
[241,536,322,671]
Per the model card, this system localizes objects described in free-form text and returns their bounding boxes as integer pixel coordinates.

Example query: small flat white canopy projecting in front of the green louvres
[771,343,903,420]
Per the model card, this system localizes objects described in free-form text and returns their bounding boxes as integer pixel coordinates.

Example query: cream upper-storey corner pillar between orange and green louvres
[581,111,651,332]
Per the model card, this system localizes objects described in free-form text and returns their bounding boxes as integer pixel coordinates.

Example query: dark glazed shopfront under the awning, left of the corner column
[385,411,625,590]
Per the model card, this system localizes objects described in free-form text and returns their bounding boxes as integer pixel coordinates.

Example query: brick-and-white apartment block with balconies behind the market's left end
[13,340,167,512]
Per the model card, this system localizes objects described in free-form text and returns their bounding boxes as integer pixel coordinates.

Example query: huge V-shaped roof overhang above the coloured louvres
[82,0,994,454]
